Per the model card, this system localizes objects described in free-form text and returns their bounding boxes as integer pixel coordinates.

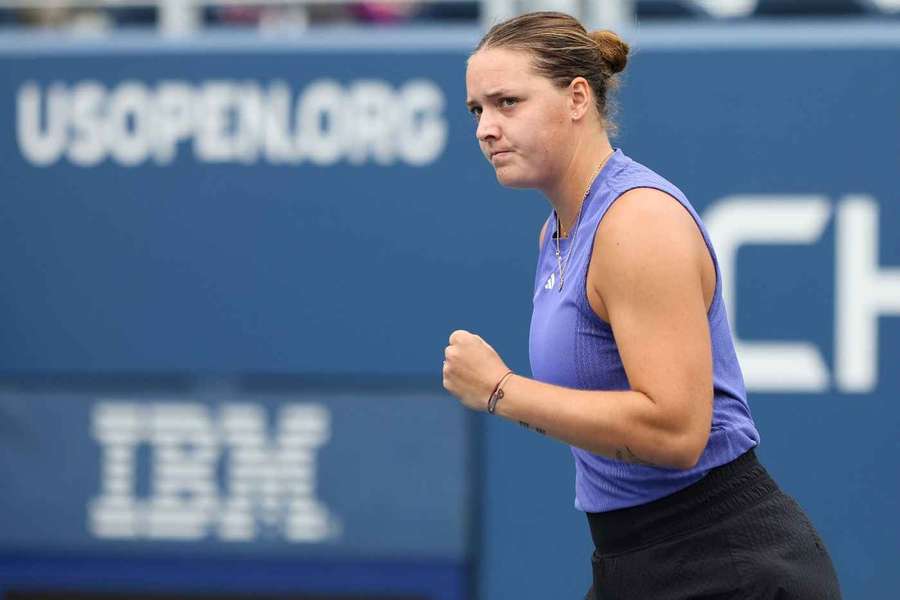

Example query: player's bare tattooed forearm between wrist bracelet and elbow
[496,375,705,469]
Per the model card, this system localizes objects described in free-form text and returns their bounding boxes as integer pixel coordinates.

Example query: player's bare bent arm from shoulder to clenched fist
[444,188,713,469]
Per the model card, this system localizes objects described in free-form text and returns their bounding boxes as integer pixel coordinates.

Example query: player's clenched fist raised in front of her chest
[444,329,509,411]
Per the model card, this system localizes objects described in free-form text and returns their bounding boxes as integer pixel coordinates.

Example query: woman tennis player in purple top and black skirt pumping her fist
[443,12,840,600]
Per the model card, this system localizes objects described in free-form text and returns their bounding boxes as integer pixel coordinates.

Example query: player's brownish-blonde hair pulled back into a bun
[473,11,629,133]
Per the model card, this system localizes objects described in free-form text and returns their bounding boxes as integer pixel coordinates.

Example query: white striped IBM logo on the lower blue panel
[88,402,340,542]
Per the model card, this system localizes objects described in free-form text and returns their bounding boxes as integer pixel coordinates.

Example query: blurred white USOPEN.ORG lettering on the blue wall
[16,79,448,167]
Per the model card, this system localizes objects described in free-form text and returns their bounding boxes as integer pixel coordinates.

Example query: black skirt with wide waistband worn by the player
[585,450,841,600]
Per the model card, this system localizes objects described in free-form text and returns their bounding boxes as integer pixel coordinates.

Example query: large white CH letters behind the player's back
[703,195,900,393]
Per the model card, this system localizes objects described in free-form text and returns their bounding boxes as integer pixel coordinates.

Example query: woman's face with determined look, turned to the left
[466,48,571,189]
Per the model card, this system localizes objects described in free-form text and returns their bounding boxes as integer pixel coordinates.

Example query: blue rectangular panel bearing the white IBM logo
[0,390,472,562]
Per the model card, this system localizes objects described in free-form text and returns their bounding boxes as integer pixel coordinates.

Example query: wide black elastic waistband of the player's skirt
[587,449,778,554]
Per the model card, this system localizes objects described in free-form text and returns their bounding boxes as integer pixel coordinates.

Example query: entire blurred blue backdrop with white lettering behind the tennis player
[0,0,900,600]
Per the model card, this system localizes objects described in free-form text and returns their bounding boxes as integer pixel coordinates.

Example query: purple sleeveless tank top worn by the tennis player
[529,150,759,512]
